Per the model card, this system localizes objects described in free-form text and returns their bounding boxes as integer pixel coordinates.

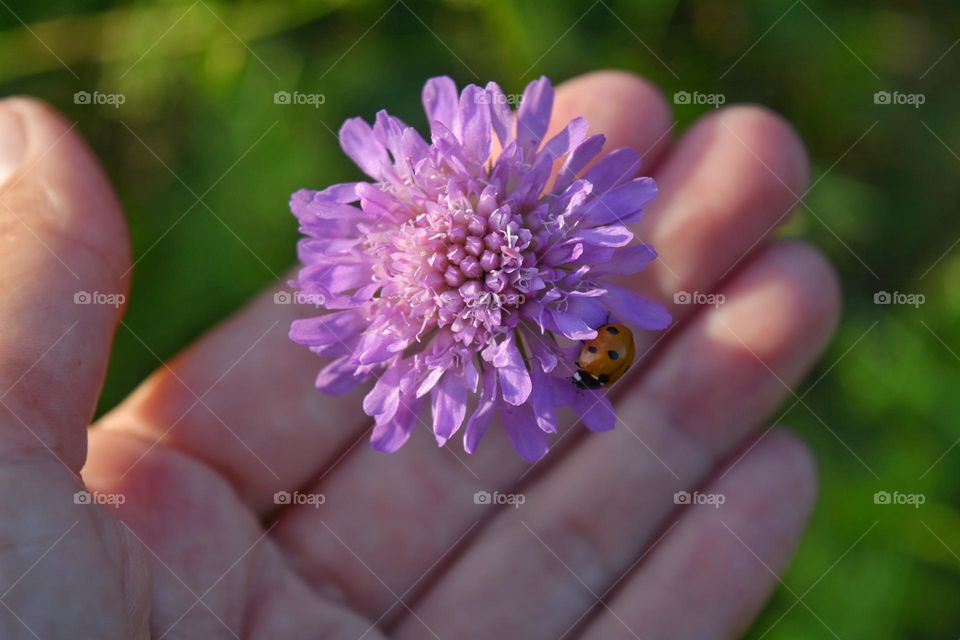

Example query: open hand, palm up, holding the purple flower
[0,71,838,640]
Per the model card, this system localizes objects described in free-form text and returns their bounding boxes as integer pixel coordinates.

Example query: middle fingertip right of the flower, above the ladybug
[630,106,809,328]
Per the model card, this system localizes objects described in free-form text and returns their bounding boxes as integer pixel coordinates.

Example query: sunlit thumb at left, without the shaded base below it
[0,98,130,473]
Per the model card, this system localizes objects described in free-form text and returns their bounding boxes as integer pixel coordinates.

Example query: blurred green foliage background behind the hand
[0,0,960,640]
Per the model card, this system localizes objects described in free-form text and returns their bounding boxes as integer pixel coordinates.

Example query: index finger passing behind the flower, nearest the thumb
[94,72,670,511]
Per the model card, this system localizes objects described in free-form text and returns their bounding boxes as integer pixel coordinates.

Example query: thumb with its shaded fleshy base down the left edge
[0,98,147,638]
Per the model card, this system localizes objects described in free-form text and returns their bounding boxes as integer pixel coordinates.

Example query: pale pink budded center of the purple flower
[370,193,543,344]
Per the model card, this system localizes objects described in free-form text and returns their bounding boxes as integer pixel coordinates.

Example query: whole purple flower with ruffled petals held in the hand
[290,77,670,461]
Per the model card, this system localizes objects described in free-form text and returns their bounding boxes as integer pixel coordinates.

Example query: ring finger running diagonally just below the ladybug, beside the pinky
[399,244,837,639]
